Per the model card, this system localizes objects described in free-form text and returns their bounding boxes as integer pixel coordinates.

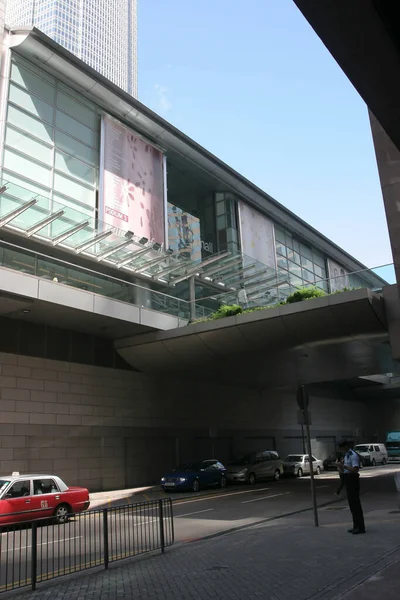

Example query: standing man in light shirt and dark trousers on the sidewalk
[338,442,365,535]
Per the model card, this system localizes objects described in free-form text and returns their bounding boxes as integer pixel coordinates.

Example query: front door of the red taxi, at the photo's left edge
[0,479,32,525]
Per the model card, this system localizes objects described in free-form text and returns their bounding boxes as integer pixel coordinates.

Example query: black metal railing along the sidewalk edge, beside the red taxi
[0,498,174,593]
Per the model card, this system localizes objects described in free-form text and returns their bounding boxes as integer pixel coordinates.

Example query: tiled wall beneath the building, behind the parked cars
[0,354,374,490]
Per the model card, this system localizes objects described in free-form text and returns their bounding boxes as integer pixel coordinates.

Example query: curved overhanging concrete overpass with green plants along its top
[115,286,397,389]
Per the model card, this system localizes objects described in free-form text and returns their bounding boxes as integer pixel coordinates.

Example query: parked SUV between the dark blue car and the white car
[225,450,283,485]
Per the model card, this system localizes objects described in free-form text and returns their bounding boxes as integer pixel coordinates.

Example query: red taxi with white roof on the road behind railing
[0,473,90,526]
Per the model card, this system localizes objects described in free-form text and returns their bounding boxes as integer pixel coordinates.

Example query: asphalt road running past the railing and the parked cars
[0,465,400,591]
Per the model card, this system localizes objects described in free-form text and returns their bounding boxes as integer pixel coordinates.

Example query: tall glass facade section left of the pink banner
[2,59,100,216]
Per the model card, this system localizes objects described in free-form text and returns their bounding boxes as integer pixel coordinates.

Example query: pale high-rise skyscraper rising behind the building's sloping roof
[6,0,137,97]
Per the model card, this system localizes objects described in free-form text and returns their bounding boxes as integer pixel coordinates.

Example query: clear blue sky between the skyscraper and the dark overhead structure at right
[139,0,392,267]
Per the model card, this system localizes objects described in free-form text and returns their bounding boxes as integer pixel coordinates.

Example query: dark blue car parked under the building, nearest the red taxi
[161,459,226,492]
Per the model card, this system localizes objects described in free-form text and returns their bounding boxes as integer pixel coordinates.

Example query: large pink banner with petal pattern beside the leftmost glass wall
[100,116,165,244]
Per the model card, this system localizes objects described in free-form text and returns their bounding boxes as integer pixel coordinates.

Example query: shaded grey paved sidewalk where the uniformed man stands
[4,494,400,600]
